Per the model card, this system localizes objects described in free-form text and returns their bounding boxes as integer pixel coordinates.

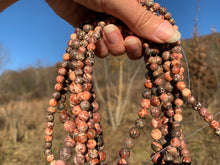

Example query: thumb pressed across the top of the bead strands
[74,0,181,43]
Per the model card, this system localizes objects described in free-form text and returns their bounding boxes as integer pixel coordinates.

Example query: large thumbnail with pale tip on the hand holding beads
[154,21,181,43]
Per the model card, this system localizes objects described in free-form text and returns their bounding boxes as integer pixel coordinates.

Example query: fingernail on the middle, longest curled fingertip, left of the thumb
[103,24,119,44]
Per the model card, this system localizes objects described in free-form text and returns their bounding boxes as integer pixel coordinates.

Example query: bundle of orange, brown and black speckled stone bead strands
[45,0,220,165]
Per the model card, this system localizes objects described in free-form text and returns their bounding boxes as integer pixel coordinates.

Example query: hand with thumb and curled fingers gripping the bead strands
[46,0,181,59]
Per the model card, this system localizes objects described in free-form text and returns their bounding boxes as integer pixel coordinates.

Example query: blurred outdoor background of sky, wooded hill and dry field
[0,0,220,165]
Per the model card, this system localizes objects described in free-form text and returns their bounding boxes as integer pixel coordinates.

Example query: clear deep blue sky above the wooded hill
[0,0,220,72]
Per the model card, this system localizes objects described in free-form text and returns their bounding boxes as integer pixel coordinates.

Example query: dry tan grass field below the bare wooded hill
[0,94,220,165]
